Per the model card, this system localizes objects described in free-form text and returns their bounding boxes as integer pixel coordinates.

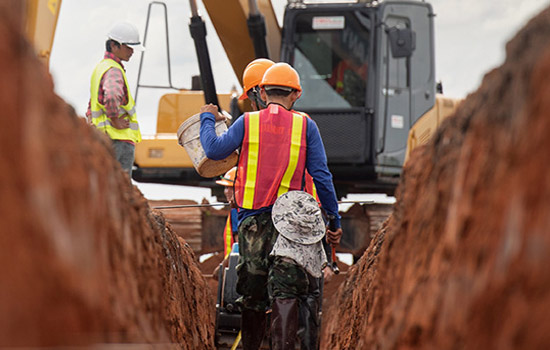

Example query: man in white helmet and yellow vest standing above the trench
[86,22,145,178]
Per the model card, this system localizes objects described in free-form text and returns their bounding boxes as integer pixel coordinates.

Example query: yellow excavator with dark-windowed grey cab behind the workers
[133,0,458,198]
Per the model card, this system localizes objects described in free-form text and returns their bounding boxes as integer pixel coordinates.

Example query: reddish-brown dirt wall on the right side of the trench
[323,9,550,349]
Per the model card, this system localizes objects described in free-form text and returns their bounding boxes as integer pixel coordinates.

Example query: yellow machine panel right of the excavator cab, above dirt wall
[405,94,462,162]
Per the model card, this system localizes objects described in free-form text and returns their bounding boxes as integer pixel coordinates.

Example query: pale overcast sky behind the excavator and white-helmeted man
[50,0,550,201]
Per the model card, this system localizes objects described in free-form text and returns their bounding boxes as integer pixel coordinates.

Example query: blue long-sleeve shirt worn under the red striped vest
[200,107,340,228]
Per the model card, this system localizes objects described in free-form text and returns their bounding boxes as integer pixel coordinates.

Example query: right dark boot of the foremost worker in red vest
[271,298,298,350]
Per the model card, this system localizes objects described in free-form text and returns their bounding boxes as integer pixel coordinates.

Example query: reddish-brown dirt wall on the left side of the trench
[0,6,214,349]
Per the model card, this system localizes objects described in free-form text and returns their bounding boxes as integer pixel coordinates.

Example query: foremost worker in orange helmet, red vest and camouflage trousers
[200,63,342,349]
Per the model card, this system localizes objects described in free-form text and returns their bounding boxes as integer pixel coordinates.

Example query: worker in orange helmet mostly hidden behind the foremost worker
[239,58,334,350]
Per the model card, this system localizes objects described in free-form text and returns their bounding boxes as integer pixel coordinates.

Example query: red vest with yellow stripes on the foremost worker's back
[235,104,307,209]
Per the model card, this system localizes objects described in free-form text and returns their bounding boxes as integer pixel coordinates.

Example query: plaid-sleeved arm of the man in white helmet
[100,68,130,129]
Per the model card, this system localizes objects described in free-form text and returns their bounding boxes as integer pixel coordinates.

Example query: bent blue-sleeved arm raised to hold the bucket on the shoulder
[200,108,244,160]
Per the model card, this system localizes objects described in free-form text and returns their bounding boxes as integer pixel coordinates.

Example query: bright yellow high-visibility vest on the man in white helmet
[90,58,141,143]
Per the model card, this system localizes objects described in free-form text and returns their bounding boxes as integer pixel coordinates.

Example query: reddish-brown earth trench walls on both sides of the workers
[0,4,550,349]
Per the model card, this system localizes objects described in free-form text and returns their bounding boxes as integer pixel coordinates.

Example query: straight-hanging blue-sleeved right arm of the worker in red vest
[306,118,340,232]
